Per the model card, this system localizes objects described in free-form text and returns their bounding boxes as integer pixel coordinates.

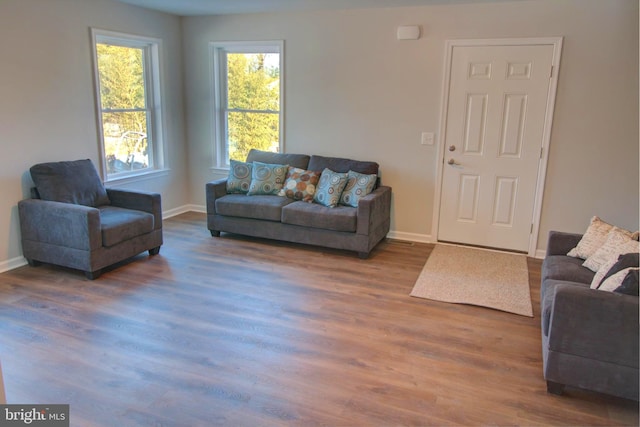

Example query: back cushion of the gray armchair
[29,159,110,207]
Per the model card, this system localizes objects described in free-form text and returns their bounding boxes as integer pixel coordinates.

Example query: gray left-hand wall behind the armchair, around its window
[0,0,190,271]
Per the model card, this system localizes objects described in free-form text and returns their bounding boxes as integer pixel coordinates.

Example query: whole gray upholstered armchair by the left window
[18,160,162,280]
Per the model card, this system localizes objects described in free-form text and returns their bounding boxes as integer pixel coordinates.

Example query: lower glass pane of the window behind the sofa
[227,112,280,161]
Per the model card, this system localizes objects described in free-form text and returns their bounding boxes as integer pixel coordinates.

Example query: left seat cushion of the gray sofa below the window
[215,194,293,221]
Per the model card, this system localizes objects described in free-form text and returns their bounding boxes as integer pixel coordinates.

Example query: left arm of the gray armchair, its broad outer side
[18,199,102,250]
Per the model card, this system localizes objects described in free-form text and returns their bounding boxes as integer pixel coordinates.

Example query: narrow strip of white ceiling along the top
[119,0,506,16]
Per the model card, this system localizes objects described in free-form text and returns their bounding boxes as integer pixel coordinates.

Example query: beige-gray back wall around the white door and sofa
[183,0,639,254]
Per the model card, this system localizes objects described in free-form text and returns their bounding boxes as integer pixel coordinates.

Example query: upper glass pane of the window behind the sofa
[226,53,280,111]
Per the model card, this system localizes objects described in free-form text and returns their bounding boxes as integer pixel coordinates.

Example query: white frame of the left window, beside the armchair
[91,28,166,182]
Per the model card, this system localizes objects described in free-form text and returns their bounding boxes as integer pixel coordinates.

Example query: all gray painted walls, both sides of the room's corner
[0,0,639,271]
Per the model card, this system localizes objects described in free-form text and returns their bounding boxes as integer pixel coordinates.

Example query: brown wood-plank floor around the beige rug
[0,213,638,426]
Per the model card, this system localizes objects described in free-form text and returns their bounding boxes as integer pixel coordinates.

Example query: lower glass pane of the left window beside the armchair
[102,111,150,174]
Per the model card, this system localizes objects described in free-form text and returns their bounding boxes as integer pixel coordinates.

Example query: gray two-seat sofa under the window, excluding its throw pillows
[206,150,391,258]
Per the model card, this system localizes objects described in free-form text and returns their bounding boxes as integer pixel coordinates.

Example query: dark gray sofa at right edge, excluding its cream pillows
[540,231,639,400]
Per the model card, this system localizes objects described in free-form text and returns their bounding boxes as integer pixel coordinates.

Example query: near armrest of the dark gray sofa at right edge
[549,283,639,367]
